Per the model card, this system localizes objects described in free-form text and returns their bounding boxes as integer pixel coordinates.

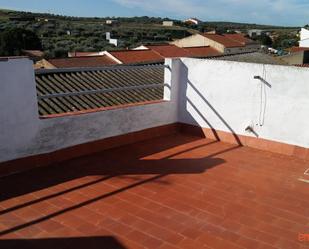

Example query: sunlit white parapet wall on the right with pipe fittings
[178,59,309,148]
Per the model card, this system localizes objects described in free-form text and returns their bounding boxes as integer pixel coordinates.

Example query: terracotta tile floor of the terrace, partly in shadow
[0,134,309,249]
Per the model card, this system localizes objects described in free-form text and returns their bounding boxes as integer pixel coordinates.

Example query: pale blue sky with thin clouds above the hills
[0,0,309,26]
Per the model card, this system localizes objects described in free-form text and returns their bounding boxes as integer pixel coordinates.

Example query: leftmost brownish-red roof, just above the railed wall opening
[48,55,118,68]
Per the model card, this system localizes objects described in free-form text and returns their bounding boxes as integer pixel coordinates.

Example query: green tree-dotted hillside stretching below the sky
[0,10,297,58]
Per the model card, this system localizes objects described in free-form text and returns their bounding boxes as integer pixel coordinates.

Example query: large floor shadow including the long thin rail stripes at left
[0,134,243,237]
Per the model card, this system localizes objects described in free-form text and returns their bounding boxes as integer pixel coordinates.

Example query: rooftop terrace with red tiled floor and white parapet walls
[0,58,309,249]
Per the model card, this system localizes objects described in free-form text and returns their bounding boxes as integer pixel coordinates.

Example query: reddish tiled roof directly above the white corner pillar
[146,44,191,58]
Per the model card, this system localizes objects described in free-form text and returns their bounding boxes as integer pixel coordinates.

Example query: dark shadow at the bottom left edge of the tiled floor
[0,236,126,249]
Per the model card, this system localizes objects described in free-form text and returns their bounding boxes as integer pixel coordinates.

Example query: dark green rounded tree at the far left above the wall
[0,28,42,56]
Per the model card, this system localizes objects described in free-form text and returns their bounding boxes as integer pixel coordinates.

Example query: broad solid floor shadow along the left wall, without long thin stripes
[0,134,223,202]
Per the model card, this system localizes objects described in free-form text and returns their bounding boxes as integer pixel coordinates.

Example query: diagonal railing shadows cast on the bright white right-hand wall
[178,60,243,146]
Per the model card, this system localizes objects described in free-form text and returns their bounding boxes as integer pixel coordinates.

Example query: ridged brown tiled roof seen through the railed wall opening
[35,65,164,116]
